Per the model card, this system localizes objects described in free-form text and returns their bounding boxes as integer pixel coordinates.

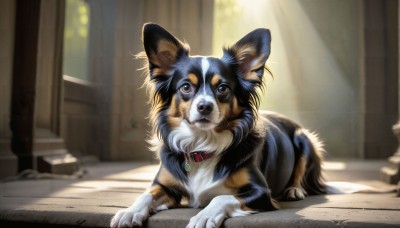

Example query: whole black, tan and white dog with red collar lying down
[110,23,326,228]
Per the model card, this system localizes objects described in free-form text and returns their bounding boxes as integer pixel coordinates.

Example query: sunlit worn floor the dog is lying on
[0,161,400,228]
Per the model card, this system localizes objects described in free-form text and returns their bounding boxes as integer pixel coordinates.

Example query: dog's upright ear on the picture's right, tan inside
[223,29,271,83]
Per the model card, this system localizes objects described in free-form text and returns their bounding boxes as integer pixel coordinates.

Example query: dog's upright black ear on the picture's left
[142,23,189,77]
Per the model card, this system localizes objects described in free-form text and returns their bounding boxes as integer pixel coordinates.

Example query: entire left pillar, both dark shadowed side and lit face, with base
[10,0,78,174]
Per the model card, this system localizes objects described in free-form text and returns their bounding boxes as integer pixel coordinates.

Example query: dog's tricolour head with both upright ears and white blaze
[143,24,271,136]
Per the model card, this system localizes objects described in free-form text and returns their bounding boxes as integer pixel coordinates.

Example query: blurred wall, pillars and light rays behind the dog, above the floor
[0,0,399,176]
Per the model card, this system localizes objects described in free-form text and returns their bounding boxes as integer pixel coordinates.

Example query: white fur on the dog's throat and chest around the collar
[169,121,233,207]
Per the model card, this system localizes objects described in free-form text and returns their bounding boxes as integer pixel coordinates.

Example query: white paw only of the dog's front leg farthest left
[110,207,148,228]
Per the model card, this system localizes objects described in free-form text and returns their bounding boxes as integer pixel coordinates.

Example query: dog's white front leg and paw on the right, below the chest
[186,195,255,228]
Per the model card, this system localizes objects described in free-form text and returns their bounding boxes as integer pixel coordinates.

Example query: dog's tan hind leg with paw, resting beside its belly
[284,156,307,200]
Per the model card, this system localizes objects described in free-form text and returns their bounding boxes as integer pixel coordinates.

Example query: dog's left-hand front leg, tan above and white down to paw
[110,185,178,227]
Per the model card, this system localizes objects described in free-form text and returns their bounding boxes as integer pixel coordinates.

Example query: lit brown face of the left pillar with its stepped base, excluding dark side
[32,0,78,174]
